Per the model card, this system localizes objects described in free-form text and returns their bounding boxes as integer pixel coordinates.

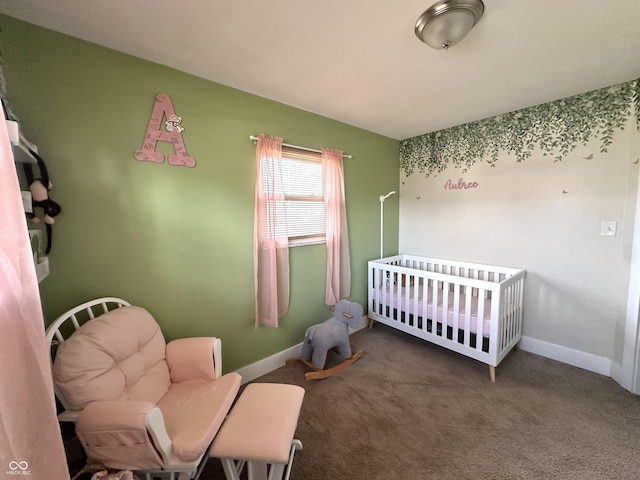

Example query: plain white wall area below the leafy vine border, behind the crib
[399,120,640,368]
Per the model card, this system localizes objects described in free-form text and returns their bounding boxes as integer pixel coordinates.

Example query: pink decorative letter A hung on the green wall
[135,93,196,167]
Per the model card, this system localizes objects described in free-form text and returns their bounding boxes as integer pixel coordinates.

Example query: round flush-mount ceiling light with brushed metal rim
[416,0,484,50]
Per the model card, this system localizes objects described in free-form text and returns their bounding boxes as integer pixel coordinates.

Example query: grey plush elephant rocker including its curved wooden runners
[286,300,364,380]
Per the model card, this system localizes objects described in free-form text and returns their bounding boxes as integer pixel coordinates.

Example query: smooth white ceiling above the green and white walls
[0,0,640,139]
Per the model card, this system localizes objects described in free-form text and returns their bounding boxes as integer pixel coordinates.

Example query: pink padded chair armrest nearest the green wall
[165,337,222,382]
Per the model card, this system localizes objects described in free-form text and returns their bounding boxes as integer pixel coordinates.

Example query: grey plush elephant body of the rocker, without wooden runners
[300,300,362,370]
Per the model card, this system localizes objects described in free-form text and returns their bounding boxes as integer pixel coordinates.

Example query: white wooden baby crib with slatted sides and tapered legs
[368,255,525,382]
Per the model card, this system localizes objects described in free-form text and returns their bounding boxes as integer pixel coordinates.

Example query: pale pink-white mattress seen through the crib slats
[371,286,491,337]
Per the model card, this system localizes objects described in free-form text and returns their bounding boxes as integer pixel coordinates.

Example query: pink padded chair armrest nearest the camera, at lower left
[76,400,172,470]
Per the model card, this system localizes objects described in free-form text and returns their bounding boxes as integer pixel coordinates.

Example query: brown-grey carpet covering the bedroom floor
[201,324,640,480]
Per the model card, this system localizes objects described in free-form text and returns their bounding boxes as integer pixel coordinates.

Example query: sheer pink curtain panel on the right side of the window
[322,148,351,305]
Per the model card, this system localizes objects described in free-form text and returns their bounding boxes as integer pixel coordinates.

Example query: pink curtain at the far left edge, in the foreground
[0,109,69,480]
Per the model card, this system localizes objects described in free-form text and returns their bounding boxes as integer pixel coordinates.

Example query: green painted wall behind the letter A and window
[0,16,399,371]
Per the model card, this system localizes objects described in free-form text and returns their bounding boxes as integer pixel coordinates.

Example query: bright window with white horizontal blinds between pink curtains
[264,147,325,246]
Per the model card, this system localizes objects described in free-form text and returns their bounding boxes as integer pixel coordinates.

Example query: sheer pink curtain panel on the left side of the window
[253,134,289,327]
